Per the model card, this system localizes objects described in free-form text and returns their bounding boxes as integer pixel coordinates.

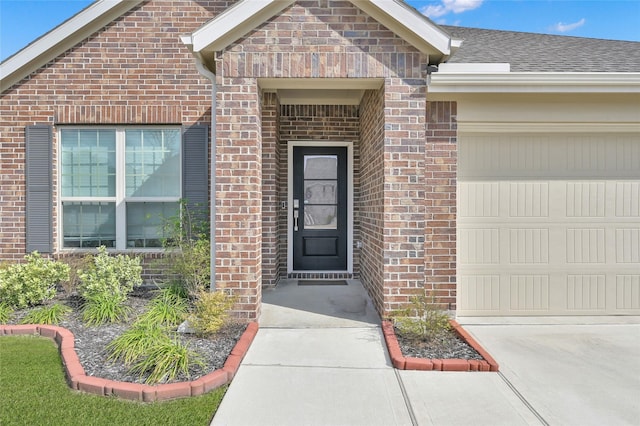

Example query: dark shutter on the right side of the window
[182,125,209,220]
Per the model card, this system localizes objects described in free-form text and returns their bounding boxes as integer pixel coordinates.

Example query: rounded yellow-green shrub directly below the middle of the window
[78,246,142,300]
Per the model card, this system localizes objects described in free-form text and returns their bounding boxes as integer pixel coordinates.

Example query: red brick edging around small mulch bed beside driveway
[382,320,499,371]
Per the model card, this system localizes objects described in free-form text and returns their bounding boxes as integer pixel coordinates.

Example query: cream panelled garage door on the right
[458,133,640,316]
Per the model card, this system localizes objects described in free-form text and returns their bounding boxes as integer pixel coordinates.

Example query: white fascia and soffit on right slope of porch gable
[352,0,452,56]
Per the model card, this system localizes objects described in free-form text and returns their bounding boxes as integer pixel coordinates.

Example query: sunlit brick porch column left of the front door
[216,78,262,320]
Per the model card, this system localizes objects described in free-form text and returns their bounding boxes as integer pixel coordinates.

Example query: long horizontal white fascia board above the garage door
[428,72,640,94]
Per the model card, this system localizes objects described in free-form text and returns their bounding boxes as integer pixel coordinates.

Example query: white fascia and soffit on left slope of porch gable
[191,0,293,52]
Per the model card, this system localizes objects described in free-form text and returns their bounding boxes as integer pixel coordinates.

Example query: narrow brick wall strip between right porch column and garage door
[424,102,458,309]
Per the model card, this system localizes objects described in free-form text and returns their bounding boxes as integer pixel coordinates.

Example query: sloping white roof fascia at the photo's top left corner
[0,0,142,92]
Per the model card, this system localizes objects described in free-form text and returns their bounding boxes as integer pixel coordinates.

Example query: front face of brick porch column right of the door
[383,78,426,313]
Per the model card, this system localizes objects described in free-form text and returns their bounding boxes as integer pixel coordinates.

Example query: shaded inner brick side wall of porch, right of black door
[358,89,384,312]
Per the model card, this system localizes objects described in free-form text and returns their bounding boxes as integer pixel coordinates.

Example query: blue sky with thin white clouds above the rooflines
[0,0,640,60]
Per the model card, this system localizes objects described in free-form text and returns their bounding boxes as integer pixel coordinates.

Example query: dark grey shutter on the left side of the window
[25,125,53,253]
